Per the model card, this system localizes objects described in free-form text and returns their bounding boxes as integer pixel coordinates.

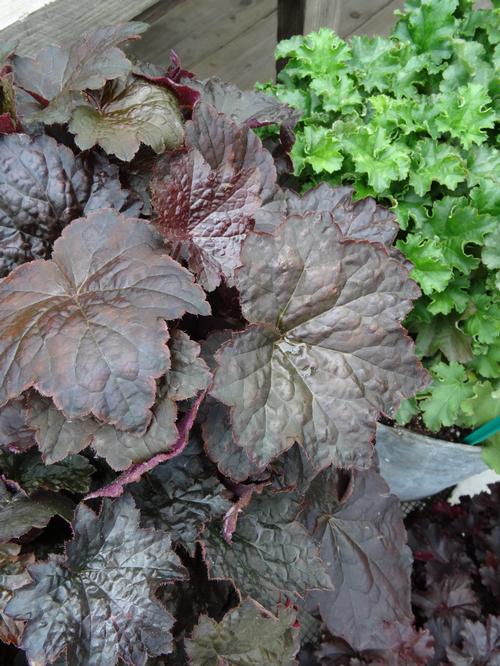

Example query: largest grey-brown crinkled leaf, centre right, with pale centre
[212,215,426,469]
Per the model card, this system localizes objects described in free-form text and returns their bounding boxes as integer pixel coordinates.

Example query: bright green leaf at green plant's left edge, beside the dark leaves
[291,125,344,175]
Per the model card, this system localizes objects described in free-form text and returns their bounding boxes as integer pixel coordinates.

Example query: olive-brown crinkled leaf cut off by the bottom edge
[186,599,299,666]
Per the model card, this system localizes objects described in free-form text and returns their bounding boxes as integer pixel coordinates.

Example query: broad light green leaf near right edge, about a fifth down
[436,83,495,150]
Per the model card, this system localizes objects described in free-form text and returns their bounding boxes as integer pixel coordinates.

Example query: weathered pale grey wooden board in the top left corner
[0,0,160,54]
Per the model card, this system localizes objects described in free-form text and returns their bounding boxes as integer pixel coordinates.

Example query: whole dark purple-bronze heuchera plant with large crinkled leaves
[0,23,430,666]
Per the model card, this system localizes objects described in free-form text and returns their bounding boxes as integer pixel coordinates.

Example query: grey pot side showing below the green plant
[376,423,488,501]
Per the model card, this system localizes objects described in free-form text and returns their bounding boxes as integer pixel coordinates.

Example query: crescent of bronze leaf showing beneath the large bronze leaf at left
[28,331,210,470]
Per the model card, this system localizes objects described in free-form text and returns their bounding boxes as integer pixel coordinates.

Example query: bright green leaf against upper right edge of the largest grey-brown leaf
[396,233,453,295]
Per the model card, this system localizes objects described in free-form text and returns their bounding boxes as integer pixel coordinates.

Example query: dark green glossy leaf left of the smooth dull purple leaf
[204,495,331,609]
